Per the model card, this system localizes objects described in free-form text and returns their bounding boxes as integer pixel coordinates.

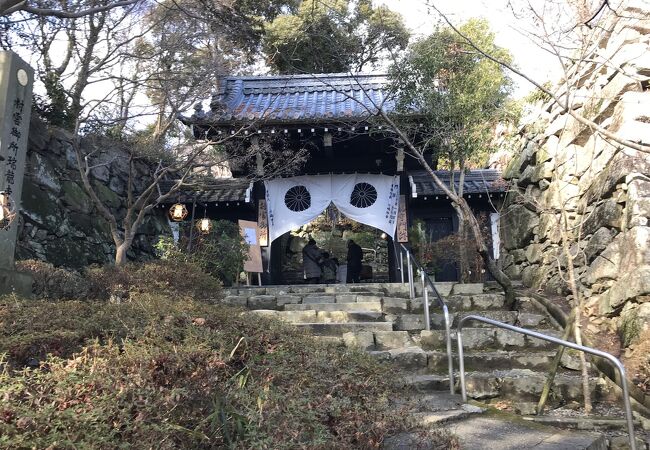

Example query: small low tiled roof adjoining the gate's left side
[160,178,251,203]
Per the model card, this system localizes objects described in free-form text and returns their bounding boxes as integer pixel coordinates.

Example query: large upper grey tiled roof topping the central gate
[181,74,395,125]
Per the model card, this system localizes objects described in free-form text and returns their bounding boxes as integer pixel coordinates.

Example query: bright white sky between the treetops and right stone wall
[375,0,560,97]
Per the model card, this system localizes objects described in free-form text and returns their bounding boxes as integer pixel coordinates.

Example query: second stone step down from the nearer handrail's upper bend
[427,350,579,374]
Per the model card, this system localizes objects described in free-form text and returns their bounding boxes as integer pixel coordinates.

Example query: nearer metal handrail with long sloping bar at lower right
[457,314,636,450]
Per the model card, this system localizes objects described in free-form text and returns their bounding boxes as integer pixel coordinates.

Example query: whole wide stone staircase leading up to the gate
[224,283,636,449]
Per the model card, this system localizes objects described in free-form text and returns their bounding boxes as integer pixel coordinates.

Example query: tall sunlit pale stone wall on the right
[501,2,650,326]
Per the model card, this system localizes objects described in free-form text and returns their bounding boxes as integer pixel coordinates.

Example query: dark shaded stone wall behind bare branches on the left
[16,119,170,268]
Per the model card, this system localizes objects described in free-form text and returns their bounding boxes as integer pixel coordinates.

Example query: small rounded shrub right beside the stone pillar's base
[16,259,90,300]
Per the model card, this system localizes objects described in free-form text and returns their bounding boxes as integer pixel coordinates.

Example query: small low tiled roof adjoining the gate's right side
[409,169,508,197]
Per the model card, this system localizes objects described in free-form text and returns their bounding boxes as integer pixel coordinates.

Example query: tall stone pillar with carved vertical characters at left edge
[0,51,34,296]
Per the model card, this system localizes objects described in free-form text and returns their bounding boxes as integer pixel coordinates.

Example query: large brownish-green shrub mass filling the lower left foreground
[0,294,447,449]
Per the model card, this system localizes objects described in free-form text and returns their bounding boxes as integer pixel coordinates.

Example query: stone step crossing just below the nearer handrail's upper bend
[420,328,562,351]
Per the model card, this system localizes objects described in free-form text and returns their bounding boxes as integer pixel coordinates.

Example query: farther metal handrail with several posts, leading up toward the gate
[400,244,454,394]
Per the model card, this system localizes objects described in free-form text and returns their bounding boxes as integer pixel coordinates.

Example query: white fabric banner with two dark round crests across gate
[264,174,399,242]
